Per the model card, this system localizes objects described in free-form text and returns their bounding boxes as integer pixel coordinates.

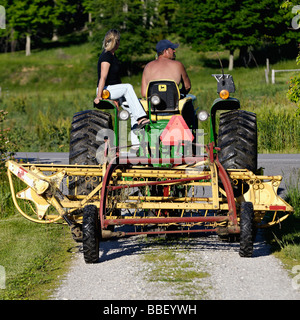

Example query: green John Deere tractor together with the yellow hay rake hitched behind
[7,74,293,263]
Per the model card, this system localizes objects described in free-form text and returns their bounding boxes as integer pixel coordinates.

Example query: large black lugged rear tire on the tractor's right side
[218,110,257,172]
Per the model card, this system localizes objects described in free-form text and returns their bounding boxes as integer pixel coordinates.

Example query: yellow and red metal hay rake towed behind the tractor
[7,144,293,262]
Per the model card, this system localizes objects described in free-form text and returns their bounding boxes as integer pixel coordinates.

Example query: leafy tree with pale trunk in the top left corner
[0,0,87,55]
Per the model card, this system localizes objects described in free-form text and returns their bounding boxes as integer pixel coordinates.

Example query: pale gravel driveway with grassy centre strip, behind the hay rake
[52,230,300,300]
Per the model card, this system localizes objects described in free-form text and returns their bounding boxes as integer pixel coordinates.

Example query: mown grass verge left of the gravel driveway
[0,215,74,300]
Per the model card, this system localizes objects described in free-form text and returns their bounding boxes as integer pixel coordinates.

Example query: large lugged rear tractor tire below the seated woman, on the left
[69,109,113,195]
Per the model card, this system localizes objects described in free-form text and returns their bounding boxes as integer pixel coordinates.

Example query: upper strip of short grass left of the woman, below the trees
[0,43,97,94]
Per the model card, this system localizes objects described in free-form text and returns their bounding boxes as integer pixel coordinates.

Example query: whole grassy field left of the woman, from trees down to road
[0,43,97,152]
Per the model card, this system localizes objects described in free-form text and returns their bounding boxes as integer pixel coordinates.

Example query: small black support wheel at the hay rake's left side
[82,205,100,263]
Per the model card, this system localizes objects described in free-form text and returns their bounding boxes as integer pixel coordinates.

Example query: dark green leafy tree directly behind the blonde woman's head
[93,0,160,72]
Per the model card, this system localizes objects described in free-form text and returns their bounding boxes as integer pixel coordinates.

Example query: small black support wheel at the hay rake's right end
[239,202,254,257]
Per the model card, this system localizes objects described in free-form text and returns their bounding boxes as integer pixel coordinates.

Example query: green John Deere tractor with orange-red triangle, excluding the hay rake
[70,74,257,175]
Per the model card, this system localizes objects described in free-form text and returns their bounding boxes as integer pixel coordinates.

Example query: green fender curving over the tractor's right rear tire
[210,97,241,143]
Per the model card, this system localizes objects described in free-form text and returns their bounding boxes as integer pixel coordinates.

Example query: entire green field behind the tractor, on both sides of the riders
[0,43,300,153]
